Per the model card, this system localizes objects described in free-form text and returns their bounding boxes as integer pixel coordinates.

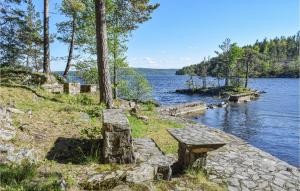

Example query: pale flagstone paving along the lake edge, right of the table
[163,116,300,191]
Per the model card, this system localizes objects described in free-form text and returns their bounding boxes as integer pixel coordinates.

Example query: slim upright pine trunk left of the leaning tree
[43,0,50,73]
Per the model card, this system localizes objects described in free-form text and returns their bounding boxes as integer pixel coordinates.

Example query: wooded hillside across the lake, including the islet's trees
[176,32,300,87]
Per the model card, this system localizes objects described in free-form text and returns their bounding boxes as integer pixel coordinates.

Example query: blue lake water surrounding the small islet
[140,70,300,167]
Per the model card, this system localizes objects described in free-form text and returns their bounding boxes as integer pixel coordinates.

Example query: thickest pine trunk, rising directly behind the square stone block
[95,0,113,108]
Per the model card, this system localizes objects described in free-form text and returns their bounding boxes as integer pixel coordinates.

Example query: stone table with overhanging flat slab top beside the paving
[168,127,226,170]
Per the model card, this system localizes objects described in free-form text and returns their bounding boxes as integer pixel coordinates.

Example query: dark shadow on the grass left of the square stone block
[46,137,102,164]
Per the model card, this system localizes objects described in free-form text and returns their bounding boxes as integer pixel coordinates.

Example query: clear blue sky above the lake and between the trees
[29,0,300,71]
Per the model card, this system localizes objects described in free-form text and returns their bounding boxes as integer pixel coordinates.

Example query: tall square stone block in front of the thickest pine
[102,109,134,164]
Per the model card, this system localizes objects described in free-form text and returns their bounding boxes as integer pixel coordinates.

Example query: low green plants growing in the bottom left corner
[0,161,61,191]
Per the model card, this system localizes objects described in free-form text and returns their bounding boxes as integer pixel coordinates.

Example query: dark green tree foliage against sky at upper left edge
[0,0,42,70]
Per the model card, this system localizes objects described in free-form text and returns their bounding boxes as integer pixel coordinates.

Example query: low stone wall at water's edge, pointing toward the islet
[158,102,206,116]
